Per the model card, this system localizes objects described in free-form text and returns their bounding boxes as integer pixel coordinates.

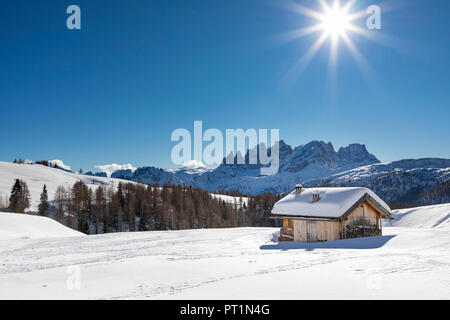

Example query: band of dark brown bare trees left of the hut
[1,179,280,234]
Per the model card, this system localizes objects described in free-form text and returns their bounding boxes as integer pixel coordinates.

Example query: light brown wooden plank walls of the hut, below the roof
[280,202,382,242]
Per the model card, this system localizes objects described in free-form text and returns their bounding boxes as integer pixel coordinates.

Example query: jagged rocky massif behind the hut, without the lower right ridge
[103,141,379,194]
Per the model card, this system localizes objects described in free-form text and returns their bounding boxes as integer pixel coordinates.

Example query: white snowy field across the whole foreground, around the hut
[0,204,450,299]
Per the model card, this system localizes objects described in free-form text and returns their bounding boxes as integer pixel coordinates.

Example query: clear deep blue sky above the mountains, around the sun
[0,0,450,170]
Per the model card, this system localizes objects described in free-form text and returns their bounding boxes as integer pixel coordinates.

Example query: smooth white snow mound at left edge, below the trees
[0,212,85,240]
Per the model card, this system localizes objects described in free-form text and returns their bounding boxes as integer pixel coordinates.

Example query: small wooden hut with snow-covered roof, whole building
[271,185,392,242]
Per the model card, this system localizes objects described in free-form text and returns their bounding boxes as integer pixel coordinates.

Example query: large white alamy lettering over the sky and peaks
[171,121,280,176]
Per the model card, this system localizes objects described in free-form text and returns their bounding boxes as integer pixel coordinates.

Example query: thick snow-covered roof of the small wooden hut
[272,187,391,219]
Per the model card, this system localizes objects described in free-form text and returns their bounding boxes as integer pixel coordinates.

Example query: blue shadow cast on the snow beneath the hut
[260,235,395,251]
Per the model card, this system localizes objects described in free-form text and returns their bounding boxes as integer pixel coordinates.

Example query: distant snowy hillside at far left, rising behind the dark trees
[0,161,130,211]
